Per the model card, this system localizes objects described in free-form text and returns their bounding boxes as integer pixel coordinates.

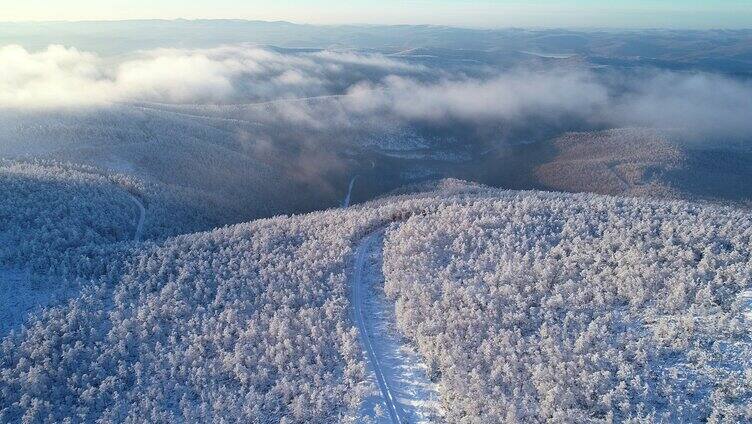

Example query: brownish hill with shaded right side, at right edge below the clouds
[535,128,752,202]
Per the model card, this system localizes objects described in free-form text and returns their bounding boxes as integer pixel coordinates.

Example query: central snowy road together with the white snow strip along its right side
[353,231,441,423]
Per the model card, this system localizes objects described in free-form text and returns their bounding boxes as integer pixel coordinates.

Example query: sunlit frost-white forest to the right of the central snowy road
[384,194,752,423]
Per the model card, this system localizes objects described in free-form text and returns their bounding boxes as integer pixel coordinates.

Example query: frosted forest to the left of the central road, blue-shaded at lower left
[0,190,406,422]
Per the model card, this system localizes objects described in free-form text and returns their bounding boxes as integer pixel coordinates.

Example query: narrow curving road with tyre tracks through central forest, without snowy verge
[352,231,405,424]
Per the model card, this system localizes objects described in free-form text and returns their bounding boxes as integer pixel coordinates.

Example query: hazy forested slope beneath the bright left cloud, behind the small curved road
[0,105,356,229]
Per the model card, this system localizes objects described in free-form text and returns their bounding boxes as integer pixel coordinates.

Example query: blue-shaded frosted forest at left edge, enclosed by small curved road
[0,162,139,272]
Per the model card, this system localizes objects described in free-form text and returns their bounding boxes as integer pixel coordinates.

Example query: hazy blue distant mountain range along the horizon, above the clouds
[0,19,752,76]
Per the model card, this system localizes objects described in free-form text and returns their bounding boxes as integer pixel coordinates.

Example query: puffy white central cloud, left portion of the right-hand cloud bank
[347,71,608,121]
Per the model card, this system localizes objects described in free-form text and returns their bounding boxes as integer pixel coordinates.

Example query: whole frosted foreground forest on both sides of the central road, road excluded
[0,181,752,422]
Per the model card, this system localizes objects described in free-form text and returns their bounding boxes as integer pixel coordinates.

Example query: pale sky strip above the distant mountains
[5,0,752,28]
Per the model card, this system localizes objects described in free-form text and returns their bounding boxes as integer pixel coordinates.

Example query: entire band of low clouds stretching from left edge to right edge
[0,46,752,136]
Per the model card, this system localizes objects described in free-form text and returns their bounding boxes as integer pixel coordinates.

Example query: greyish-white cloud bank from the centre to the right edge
[343,69,752,137]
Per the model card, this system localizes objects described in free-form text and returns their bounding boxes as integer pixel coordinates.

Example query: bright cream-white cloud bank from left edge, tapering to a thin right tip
[0,45,421,109]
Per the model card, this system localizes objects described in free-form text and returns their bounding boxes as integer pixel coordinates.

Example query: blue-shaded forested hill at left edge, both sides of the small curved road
[0,160,220,278]
